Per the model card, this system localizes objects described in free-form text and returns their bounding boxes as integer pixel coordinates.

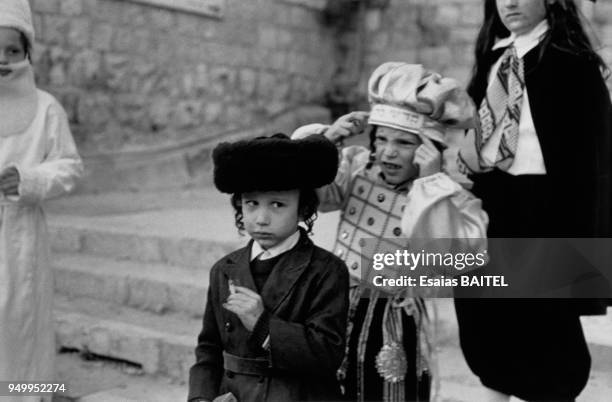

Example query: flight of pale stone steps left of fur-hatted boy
[51,210,243,382]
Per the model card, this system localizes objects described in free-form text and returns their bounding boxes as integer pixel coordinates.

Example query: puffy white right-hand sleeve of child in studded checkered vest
[402,173,489,252]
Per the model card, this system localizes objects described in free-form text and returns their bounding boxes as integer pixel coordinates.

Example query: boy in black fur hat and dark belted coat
[188,134,348,402]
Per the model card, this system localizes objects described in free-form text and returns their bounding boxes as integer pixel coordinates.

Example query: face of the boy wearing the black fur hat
[242,190,300,249]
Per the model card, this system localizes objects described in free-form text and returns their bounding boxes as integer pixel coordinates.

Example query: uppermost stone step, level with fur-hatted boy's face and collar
[49,210,246,269]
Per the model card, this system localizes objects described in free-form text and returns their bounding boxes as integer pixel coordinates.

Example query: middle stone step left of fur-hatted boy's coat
[53,253,209,317]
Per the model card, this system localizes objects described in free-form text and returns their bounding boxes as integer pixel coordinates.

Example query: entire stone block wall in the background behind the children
[30,0,612,191]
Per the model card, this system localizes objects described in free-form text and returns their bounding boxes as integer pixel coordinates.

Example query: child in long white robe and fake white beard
[0,0,82,392]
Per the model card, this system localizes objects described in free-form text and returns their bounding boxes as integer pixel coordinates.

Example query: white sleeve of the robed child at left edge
[15,104,83,203]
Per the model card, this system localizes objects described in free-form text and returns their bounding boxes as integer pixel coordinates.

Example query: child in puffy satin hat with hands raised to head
[293,63,487,401]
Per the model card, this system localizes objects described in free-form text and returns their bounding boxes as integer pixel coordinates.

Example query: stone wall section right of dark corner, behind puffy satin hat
[360,0,612,97]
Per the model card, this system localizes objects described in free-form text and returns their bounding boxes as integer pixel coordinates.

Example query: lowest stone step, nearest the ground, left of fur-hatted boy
[55,294,202,382]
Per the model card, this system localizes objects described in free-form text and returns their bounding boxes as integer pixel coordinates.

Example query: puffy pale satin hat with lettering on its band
[368,62,476,144]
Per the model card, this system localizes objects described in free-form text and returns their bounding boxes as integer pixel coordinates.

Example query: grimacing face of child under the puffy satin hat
[375,126,421,184]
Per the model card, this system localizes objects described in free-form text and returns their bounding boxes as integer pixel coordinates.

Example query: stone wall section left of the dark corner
[31,0,335,155]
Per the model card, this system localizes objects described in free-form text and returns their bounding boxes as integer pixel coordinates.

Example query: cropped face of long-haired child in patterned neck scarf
[496,0,546,35]
